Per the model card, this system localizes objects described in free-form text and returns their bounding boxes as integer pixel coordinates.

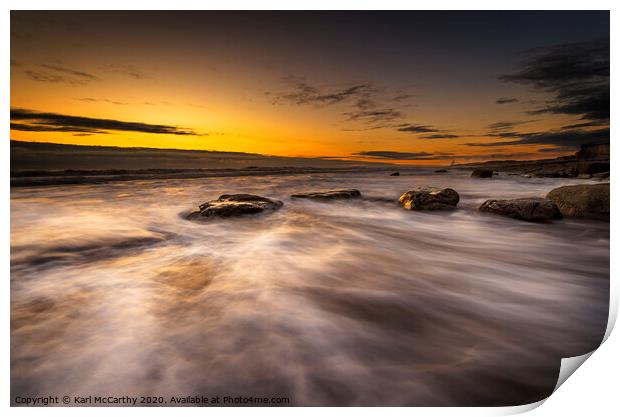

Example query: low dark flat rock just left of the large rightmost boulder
[478,197,562,222]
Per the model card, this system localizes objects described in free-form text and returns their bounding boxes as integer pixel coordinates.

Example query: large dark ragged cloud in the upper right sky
[500,37,609,120]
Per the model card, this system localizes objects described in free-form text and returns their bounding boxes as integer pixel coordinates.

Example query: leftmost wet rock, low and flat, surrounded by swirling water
[187,194,283,219]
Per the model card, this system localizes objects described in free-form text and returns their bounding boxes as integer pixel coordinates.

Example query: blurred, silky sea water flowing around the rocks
[11,168,609,405]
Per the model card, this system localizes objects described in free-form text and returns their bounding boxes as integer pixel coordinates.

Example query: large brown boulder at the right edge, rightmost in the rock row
[547,183,609,221]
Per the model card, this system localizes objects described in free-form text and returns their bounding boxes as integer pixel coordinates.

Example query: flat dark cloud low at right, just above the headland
[465,128,609,147]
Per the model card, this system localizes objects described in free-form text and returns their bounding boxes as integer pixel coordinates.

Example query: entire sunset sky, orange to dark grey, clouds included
[11,11,609,164]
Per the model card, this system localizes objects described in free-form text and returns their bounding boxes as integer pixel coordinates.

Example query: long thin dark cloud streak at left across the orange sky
[11,109,197,135]
